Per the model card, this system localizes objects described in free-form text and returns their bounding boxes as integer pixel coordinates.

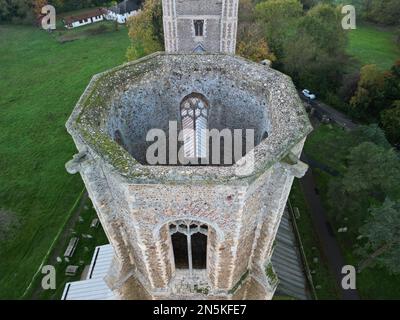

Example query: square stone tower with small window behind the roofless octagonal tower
[162,0,239,54]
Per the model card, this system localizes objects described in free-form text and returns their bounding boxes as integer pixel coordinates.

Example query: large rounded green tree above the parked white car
[282,4,347,96]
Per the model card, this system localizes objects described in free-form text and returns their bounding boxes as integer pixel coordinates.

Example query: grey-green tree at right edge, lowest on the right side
[358,198,400,274]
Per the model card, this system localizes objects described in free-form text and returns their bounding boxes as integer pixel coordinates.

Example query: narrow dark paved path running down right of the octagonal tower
[300,154,360,300]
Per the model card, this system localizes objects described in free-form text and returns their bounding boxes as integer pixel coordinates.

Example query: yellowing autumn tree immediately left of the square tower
[127,0,164,60]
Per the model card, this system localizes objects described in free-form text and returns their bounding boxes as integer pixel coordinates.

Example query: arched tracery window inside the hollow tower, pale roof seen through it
[181,93,209,159]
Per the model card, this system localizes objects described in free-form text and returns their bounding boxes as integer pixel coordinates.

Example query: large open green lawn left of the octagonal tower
[0,22,129,299]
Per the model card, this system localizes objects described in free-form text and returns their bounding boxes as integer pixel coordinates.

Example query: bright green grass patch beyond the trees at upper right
[347,24,400,70]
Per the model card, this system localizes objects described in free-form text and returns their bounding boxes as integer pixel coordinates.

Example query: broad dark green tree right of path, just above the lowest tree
[328,142,400,233]
